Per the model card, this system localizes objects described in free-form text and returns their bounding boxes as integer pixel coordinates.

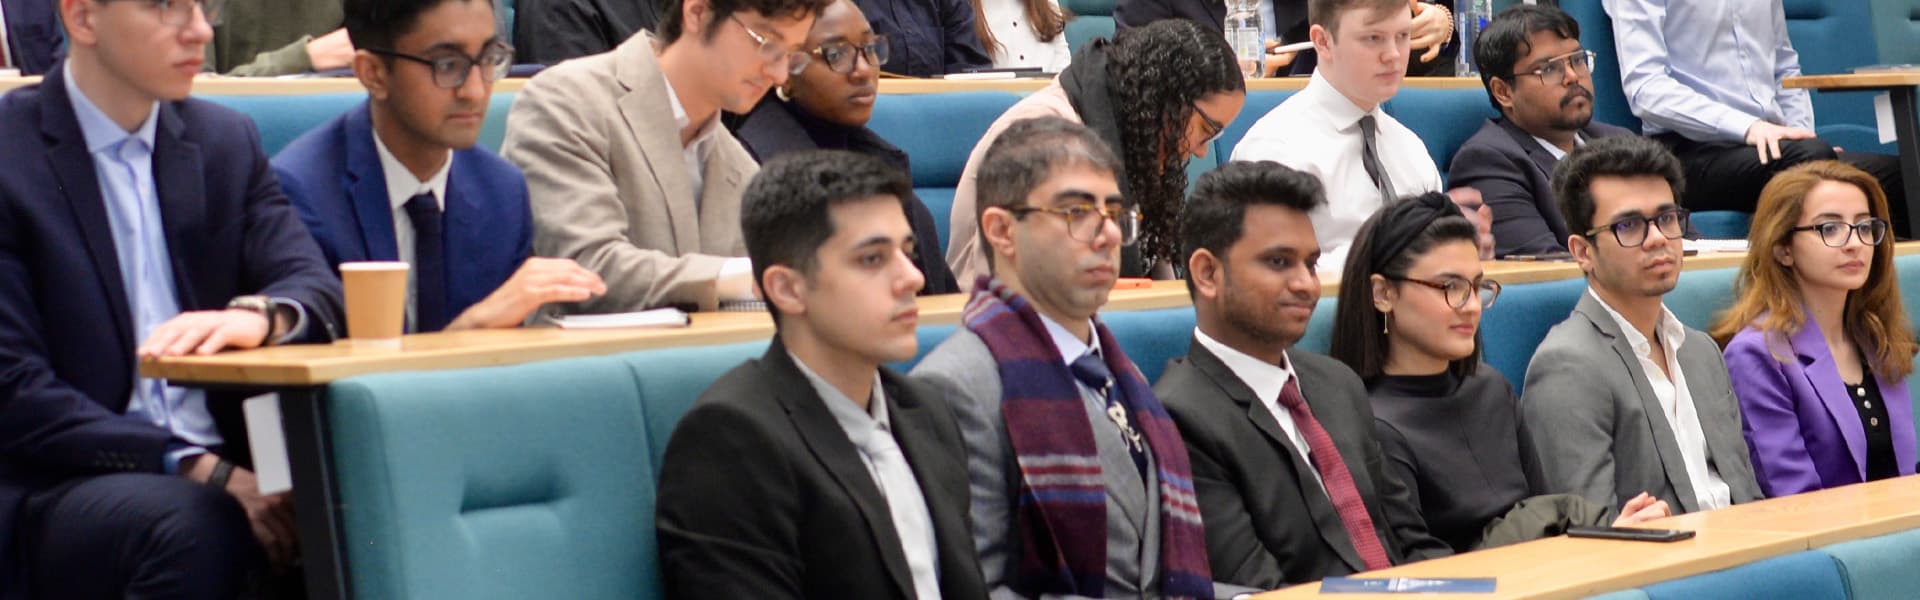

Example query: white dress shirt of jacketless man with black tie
[1233,71,1440,273]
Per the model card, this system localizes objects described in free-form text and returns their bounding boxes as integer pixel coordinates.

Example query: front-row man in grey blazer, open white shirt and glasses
[1521,137,1761,513]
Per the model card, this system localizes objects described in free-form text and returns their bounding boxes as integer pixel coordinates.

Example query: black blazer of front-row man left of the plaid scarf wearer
[655,335,987,600]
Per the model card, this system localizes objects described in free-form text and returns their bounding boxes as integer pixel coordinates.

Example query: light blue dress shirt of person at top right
[1601,0,1812,142]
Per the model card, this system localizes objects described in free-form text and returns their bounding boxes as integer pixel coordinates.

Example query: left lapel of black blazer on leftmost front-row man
[760,338,914,598]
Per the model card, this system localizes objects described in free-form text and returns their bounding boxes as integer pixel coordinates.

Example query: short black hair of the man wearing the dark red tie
[1179,160,1327,296]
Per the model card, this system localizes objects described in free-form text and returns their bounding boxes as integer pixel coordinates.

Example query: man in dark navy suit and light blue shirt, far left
[0,0,340,598]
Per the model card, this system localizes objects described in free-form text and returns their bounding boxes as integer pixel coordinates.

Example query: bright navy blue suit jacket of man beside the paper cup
[273,102,534,328]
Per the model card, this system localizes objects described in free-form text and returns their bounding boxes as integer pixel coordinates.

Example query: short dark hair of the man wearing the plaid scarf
[973,117,1119,267]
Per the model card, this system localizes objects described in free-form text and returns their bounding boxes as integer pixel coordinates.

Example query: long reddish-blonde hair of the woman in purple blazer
[1713,160,1920,379]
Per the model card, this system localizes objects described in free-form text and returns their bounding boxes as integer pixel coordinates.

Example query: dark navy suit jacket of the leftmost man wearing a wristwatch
[0,65,340,596]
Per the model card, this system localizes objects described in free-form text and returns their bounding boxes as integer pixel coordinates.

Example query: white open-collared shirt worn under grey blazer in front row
[1586,288,1734,510]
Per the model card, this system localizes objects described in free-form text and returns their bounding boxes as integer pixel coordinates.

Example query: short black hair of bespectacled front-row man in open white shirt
[1553,135,1686,236]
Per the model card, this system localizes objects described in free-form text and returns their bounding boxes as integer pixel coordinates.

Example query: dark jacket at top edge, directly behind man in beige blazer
[513,0,664,65]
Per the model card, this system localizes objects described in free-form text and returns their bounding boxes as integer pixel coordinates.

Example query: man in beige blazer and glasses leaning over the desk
[501,0,828,312]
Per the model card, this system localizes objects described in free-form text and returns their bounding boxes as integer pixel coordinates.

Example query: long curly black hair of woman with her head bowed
[1106,19,1246,265]
